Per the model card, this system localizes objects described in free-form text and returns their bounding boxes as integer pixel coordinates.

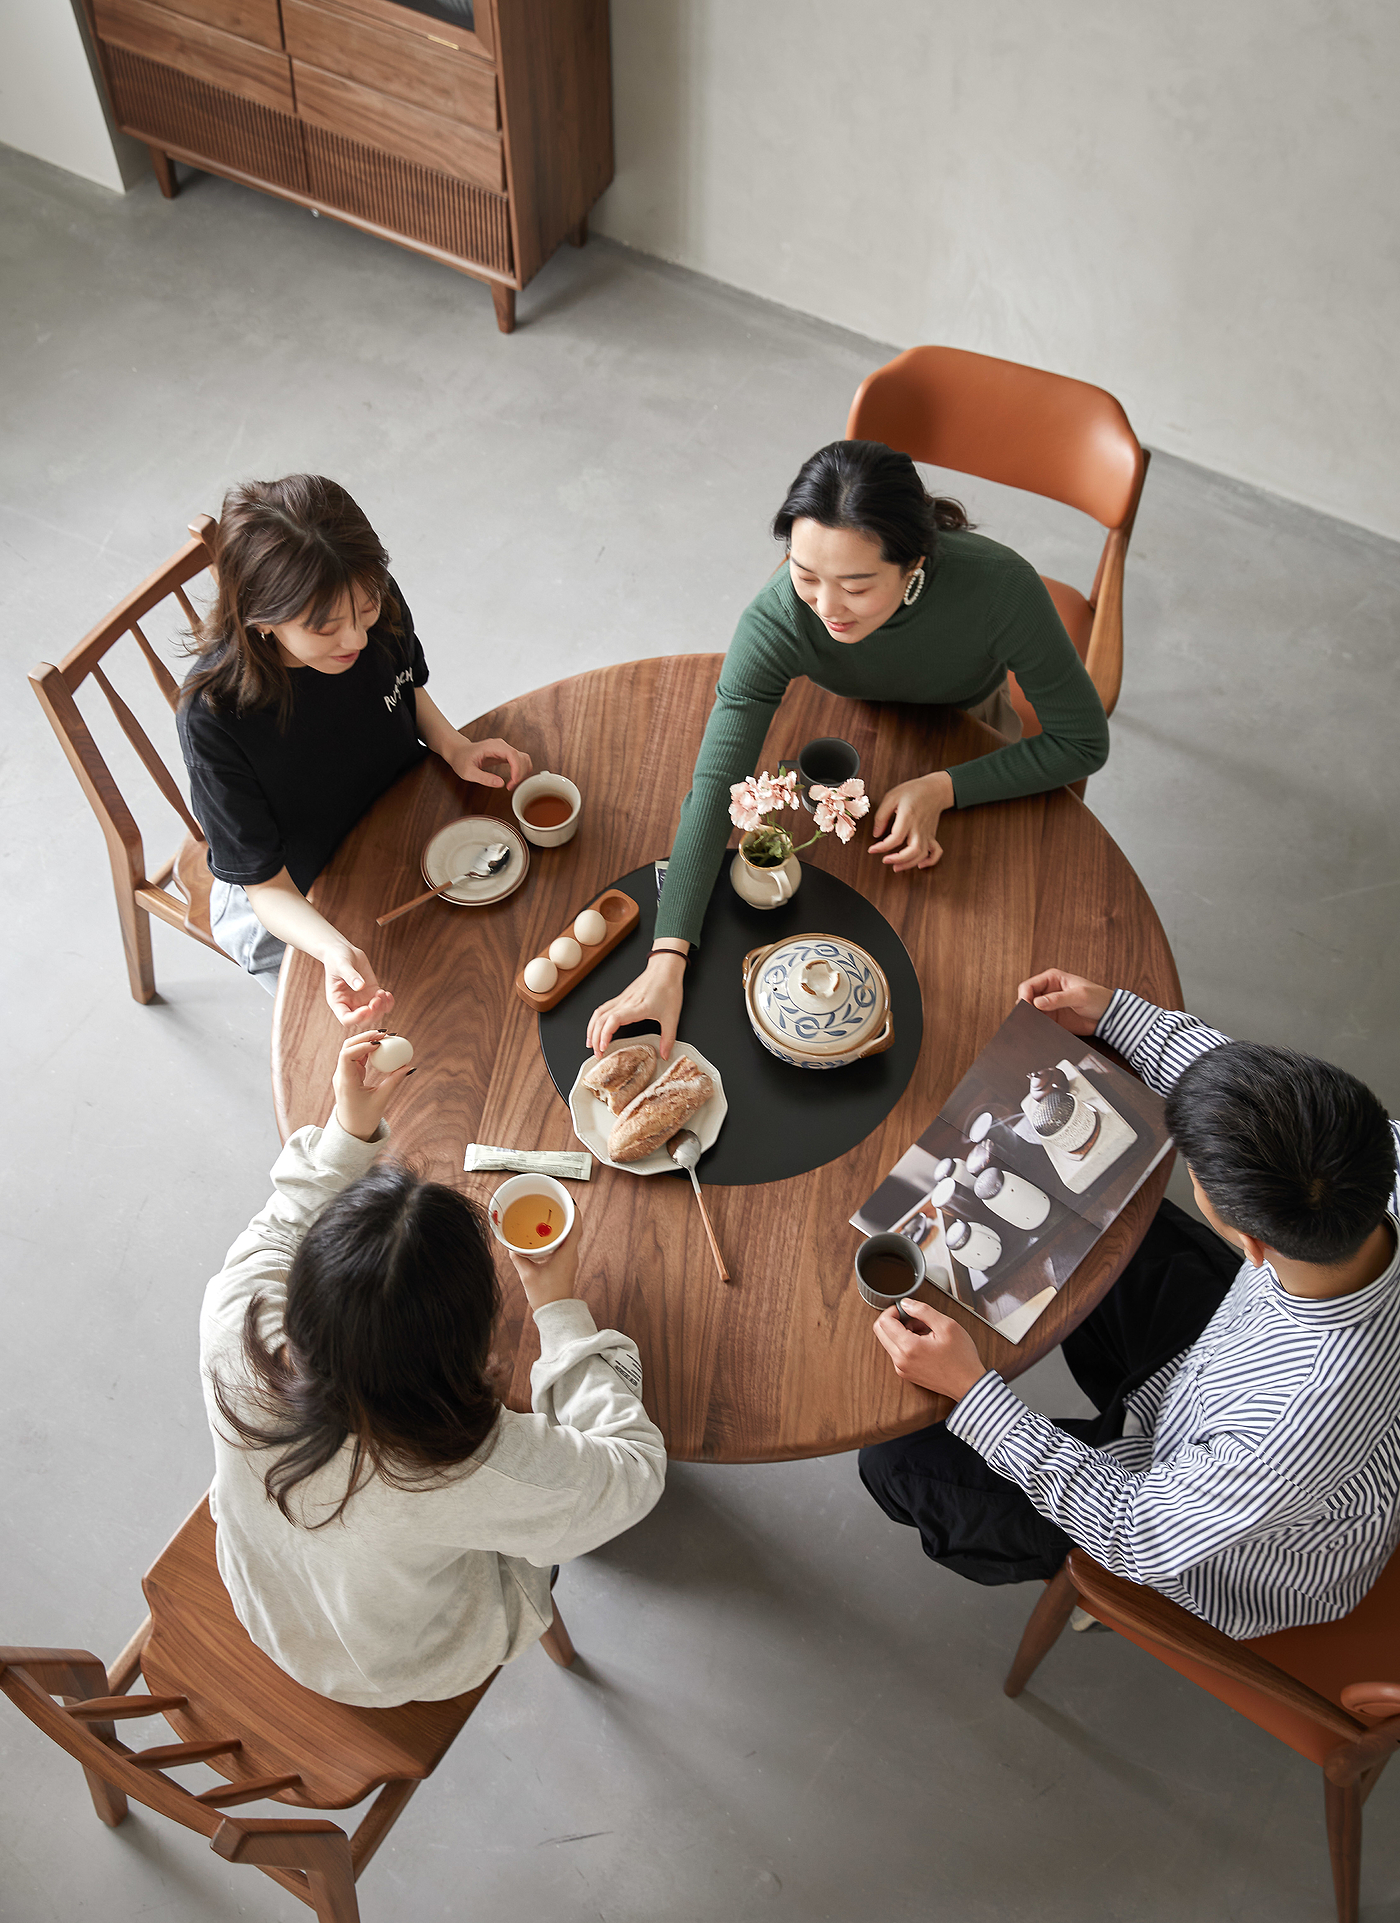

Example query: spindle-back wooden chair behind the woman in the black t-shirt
[29,513,227,1002]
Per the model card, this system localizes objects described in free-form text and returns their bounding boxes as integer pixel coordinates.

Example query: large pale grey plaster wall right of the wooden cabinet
[596,0,1400,537]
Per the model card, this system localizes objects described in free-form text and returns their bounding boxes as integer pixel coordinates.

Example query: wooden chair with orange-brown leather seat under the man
[1004,1550,1400,1923]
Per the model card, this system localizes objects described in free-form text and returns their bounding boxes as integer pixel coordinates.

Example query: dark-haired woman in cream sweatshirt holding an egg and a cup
[200,1033,665,1708]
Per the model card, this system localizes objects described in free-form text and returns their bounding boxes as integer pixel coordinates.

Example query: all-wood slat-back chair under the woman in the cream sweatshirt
[0,1500,573,1923]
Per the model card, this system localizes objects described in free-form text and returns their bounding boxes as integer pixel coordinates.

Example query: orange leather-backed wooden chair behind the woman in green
[846,348,1152,735]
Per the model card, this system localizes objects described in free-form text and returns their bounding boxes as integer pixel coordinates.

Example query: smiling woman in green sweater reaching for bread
[588,440,1108,1058]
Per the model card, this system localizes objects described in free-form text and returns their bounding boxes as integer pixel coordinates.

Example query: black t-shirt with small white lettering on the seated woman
[177,581,427,894]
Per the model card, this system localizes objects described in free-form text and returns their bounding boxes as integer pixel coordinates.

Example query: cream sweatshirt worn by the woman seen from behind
[200,1119,665,1710]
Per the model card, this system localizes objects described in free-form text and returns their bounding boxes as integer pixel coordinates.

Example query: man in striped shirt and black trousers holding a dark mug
[862,969,1400,1638]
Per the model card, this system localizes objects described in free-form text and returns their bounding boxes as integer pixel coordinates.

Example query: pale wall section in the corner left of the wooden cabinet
[0,0,150,194]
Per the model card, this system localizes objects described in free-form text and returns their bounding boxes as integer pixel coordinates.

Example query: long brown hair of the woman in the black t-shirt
[183,475,398,727]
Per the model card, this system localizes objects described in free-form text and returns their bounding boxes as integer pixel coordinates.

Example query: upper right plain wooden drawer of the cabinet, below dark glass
[283,0,500,133]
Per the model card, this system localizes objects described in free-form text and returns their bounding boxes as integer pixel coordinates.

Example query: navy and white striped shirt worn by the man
[948,988,1400,1638]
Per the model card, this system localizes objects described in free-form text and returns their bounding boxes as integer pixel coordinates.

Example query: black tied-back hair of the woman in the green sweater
[773,440,971,569]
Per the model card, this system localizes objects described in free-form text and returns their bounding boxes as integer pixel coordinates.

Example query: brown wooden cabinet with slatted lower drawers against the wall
[85,0,613,333]
